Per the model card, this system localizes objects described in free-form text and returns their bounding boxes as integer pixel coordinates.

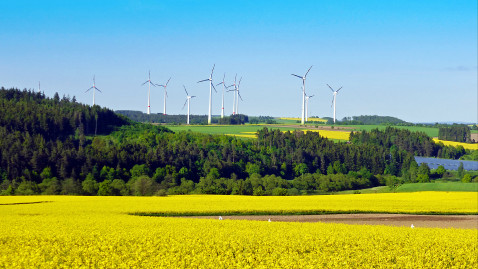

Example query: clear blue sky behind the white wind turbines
[0,0,478,122]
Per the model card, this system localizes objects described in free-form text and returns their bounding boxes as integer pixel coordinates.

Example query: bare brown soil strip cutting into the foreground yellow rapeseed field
[186,214,478,229]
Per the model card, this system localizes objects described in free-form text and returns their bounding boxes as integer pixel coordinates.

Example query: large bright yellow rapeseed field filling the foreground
[0,192,478,268]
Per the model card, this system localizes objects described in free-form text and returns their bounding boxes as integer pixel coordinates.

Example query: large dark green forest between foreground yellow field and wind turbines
[0,88,474,195]
